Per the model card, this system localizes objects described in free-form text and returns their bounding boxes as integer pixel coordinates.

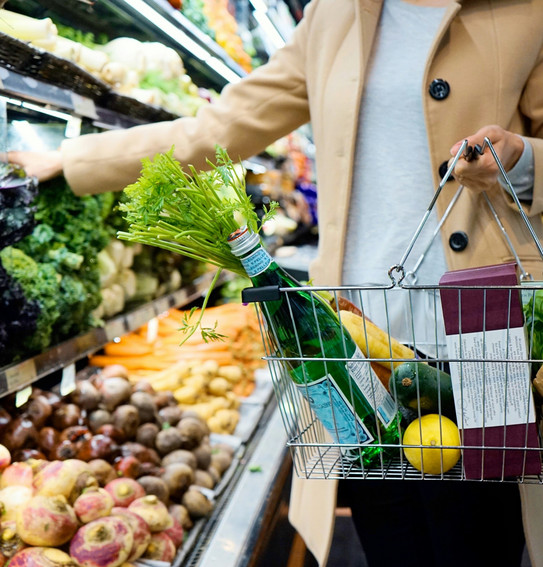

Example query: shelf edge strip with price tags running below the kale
[0,272,230,396]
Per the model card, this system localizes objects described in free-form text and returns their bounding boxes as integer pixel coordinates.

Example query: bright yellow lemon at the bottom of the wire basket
[403,413,460,474]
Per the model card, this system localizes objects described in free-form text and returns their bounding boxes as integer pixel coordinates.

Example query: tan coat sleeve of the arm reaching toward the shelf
[61,4,312,195]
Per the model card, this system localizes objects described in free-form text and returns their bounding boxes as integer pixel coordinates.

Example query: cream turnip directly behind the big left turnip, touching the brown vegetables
[34,459,98,502]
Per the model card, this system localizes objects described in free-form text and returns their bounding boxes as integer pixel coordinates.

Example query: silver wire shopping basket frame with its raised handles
[251,138,543,484]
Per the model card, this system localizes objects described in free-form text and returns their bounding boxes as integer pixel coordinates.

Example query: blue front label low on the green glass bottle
[295,375,374,445]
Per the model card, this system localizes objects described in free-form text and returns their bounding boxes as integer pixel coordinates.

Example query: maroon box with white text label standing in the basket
[439,263,541,479]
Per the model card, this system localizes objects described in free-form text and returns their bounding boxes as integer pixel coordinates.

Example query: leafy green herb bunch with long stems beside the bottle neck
[117,146,278,342]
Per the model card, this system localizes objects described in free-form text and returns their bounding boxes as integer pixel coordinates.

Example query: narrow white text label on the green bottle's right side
[347,347,396,427]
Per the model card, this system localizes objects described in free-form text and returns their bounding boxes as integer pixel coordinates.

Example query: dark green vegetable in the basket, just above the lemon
[389,361,456,422]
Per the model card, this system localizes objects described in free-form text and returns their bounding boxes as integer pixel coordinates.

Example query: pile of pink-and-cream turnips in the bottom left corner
[0,446,191,567]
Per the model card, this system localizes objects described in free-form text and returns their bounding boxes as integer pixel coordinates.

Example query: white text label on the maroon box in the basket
[447,327,535,429]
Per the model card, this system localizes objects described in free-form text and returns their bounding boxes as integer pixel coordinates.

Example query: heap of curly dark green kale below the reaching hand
[0,180,113,365]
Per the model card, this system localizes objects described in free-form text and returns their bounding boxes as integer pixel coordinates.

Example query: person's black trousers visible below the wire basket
[338,480,524,567]
